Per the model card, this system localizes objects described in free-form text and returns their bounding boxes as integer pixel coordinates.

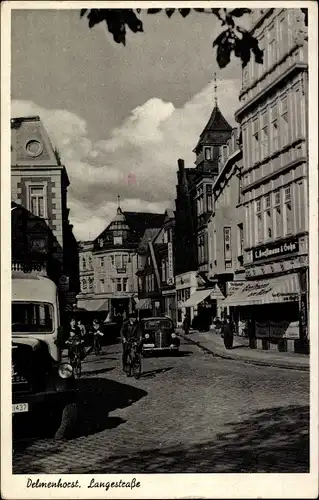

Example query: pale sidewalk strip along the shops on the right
[178,329,310,371]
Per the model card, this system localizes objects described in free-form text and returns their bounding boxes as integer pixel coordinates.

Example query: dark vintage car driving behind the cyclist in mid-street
[139,316,180,354]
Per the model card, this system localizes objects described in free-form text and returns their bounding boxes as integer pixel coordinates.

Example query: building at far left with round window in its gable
[11,116,79,311]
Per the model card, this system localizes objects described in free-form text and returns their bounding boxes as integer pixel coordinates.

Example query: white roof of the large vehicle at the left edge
[12,272,57,304]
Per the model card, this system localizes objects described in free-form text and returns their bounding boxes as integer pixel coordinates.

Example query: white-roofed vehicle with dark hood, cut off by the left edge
[11,272,77,439]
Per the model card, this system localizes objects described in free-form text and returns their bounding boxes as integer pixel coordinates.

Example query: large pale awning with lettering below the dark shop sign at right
[222,273,300,306]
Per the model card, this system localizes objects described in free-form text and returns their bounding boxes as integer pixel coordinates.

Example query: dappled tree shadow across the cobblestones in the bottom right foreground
[73,406,309,474]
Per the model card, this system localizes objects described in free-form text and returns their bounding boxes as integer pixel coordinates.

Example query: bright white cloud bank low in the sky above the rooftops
[11,80,240,239]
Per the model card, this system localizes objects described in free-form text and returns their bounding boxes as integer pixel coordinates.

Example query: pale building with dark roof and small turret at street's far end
[78,207,164,315]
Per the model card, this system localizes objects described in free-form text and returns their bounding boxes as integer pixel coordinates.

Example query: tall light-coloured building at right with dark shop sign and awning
[225,8,308,350]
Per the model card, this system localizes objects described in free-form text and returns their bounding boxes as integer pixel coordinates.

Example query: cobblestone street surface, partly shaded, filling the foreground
[13,341,309,474]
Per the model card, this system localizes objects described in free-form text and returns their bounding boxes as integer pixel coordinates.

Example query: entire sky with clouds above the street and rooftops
[11,10,248,239]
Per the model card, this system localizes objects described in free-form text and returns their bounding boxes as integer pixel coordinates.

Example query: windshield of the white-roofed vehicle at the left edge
[12,302,53,333]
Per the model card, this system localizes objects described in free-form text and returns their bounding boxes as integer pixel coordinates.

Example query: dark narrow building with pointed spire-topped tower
[175,102,232,324]
